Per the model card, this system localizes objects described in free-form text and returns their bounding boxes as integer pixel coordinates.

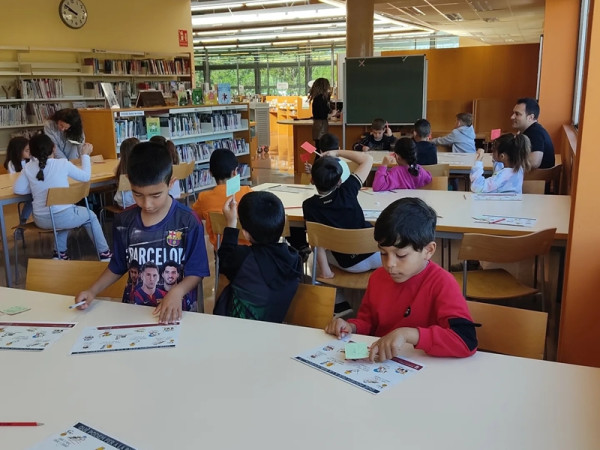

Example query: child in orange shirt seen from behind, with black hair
[192,148,252,252]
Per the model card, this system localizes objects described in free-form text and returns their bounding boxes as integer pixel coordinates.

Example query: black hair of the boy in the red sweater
[374,197,437,252]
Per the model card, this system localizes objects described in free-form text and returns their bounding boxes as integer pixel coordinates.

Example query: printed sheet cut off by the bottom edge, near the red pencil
[29,422,135,450]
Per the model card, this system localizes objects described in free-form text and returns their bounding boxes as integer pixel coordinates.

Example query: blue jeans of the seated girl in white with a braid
[33,205,109,253]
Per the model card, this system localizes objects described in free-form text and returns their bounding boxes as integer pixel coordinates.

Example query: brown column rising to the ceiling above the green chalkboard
[346,0,375,57]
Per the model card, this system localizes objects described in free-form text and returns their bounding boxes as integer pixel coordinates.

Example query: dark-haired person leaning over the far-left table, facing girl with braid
[44,108,91,160]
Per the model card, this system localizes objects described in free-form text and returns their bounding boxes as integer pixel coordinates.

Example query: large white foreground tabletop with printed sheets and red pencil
[0,287,600,450]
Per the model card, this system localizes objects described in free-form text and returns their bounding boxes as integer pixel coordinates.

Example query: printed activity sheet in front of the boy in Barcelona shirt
[71,323,181,355]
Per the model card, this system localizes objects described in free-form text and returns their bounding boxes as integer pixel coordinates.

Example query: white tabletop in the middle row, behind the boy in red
[252,183,571,241]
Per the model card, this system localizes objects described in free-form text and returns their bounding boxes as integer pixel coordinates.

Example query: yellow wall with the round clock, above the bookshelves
[0,0,193,53]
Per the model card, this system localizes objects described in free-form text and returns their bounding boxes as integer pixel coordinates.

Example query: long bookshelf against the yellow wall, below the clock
[0,47,193,152]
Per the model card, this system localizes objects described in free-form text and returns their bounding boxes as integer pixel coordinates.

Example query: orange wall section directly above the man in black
[539,0,580,143]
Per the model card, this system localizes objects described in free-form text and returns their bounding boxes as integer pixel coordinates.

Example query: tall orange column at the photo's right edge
[555,1,600,367]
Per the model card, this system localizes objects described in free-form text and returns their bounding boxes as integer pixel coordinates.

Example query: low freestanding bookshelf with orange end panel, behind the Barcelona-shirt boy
[79,103,251,191]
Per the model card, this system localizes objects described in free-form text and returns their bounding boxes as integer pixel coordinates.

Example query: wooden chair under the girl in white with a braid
[13,182,100,280]
